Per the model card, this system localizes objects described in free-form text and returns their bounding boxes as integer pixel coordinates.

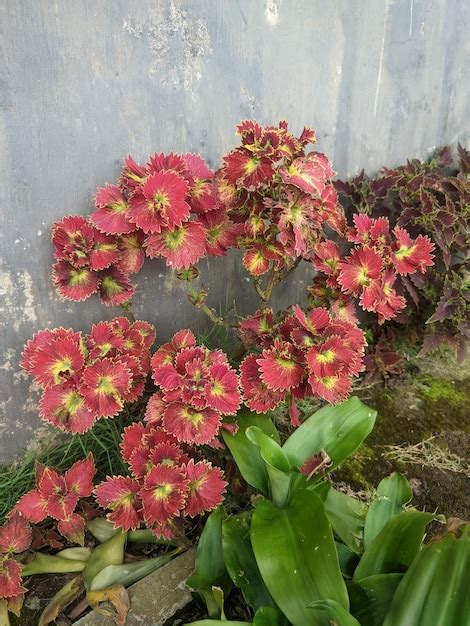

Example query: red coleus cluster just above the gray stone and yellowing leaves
[95,422,227,539]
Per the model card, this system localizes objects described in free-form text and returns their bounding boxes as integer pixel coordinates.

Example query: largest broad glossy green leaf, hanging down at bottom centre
[251,490,348,626]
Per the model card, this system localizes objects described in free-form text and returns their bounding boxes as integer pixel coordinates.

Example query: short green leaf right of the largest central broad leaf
[325,487,367,554]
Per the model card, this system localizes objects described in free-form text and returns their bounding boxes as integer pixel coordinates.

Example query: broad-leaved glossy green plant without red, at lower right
[187,398,470,626]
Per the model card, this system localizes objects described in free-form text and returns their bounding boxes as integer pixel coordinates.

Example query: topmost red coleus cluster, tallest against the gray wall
[216,120,345,276]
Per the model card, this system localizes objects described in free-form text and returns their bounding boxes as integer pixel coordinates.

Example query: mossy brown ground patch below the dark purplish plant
[334,355,470,519]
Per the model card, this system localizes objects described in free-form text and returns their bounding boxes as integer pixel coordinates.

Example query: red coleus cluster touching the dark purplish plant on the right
[312,214,434,324]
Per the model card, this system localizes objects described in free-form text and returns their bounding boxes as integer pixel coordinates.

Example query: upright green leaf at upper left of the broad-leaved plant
[222,409,279,495]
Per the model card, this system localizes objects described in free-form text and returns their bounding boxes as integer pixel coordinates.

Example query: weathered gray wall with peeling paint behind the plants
[0,0,470,461]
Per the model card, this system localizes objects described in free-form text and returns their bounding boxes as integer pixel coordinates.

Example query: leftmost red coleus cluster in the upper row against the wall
[52,215,144,305]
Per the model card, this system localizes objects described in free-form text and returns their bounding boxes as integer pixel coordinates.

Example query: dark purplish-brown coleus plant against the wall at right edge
[334,145,470,359]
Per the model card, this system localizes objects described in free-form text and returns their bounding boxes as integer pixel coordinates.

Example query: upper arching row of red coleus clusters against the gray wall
[47,120,440,344]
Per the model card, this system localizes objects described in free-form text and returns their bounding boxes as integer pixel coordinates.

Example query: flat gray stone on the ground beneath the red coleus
[75,549,196,626]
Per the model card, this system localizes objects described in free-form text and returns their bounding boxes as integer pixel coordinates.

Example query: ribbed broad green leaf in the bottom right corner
[383,524,470,626]
